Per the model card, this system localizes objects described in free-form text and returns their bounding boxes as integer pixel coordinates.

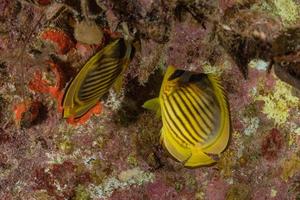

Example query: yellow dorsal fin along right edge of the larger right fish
[202,75,230,154]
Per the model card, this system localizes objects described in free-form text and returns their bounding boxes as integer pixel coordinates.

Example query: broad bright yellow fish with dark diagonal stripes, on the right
[144,66,230,167]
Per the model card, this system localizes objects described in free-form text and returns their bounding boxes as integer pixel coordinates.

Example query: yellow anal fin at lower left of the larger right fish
[161,128,191,162]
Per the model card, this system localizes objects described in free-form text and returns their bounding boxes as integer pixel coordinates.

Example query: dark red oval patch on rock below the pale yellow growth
[261,128,283,160]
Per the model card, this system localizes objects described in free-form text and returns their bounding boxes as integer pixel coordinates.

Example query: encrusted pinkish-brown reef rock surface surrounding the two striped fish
[0,0,300,200]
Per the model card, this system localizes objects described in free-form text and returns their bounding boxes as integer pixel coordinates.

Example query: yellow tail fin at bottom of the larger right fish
[184,147,216,167]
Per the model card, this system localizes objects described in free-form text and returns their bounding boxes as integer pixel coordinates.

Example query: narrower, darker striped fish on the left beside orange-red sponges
[63,38,131,118]
